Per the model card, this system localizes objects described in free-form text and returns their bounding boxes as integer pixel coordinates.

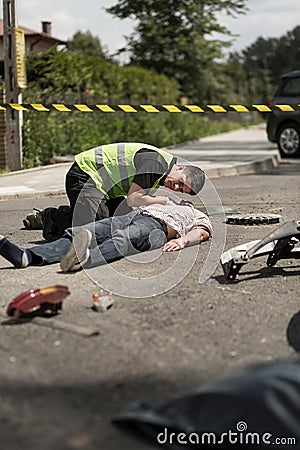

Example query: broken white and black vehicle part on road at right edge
[221,220,300,281]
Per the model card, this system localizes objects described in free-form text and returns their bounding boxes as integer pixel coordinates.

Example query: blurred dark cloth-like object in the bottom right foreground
[114,359,300,450]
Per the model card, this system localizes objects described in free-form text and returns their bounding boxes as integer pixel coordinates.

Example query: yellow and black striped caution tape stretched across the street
[0,103,300,113]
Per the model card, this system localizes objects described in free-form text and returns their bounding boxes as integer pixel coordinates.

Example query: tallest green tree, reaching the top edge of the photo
[107,0,247,101]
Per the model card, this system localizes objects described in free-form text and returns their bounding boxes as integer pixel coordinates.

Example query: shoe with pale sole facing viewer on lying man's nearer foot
[60,229,92,272]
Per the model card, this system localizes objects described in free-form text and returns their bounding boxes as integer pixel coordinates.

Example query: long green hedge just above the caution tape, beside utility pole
[23,48,179,103]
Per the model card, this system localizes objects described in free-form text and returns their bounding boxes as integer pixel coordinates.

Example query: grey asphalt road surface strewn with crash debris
[0,160,300,450]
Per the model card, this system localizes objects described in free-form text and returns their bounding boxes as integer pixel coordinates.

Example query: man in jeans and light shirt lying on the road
[0,202,212,272]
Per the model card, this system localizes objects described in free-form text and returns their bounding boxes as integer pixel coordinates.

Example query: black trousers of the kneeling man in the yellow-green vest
[50,162,131,230]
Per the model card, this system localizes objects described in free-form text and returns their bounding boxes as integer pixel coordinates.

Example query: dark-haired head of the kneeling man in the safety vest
[164,164,205,195]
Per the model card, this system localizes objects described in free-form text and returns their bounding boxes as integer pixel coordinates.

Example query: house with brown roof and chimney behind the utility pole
[0,19,67,79]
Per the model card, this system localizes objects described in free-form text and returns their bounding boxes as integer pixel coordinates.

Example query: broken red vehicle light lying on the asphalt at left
[6,284,70,318]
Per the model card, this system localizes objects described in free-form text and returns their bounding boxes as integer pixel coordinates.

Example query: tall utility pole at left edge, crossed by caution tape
[3,0,22,170]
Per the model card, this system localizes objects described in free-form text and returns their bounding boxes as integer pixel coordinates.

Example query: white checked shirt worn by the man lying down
[135,203,212,236]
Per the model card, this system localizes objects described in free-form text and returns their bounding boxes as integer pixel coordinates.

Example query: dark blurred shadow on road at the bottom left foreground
[0,373,205,450]
